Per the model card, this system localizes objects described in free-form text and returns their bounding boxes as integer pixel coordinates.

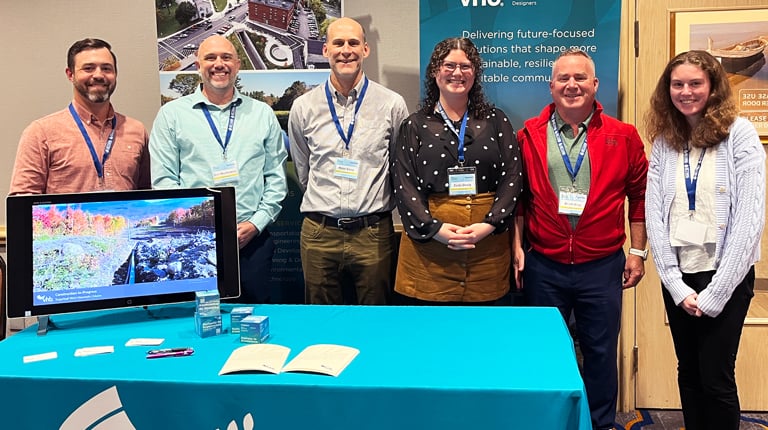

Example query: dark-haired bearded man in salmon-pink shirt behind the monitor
[10,38,149,194]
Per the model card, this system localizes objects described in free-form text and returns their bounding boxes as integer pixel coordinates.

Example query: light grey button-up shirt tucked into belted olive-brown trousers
[288,74,408,218]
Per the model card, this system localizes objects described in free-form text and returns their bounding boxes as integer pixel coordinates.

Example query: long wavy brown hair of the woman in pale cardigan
[644,51,737,151]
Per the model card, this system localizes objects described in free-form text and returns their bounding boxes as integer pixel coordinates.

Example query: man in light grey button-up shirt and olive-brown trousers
[288,18,408,305]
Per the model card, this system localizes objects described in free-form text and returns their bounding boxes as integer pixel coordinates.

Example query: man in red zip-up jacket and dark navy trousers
[513,50,648,429]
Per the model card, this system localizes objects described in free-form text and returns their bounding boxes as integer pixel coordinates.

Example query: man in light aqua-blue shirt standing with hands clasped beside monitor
[149,35,288,303]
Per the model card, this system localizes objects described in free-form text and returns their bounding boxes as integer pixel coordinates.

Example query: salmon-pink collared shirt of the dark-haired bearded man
[10,101,150,194]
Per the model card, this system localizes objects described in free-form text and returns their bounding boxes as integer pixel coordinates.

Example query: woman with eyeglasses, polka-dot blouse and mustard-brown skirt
[390,38,523,305]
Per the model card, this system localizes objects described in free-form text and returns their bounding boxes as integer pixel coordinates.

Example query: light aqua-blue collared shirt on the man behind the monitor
[149,88,288,231]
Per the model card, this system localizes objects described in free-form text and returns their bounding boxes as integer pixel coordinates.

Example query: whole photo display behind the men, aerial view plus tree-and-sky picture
[156,0,342,139]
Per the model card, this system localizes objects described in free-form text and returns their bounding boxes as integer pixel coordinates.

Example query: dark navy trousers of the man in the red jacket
[523,249,626,429]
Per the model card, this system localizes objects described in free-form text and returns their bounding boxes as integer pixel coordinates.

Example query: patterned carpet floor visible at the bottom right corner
[616,409,768,430]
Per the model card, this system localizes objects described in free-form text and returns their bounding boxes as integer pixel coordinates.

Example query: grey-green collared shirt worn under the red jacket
[547,111,592,229]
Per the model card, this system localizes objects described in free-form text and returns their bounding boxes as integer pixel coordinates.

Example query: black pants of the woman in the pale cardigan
[662,267,755,430]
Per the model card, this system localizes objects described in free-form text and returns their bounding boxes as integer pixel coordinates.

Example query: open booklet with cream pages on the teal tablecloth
[219,343,360,376]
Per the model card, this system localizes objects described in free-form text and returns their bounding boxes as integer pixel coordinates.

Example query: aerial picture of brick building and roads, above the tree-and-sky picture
[155,0,342,71]
